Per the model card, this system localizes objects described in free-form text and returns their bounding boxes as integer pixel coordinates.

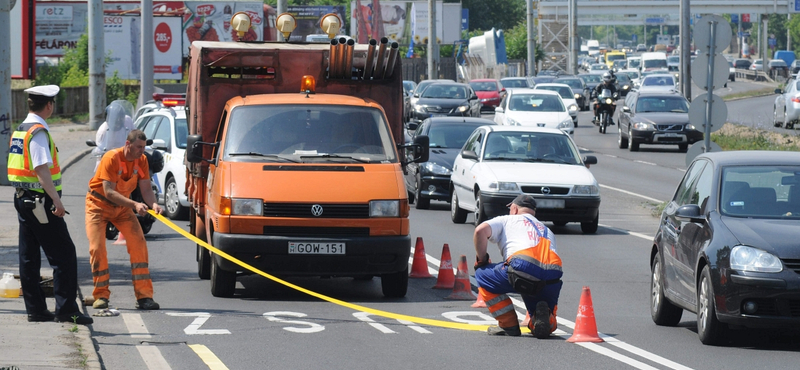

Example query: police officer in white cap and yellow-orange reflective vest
[8,85,93,325]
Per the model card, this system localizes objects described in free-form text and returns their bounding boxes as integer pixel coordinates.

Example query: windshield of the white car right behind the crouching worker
[483,131,581,164]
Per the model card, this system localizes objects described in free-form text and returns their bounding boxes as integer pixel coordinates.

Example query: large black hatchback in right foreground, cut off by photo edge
[649,151,800,344]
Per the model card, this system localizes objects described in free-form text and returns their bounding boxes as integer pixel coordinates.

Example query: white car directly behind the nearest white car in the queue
[494,88,575,134]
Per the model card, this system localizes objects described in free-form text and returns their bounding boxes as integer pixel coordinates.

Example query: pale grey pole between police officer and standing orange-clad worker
[89,0,105,130]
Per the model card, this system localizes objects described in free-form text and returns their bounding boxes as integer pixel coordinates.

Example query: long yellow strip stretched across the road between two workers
[148,210,489,331]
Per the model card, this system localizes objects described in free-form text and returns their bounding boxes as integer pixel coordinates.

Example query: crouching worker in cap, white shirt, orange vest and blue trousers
[473,194,563,339]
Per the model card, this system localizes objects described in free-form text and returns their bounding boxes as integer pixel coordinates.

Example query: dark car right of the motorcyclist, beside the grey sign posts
[617,91,703,152]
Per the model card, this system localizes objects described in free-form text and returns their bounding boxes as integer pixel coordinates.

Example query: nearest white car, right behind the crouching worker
[450,126,600,234]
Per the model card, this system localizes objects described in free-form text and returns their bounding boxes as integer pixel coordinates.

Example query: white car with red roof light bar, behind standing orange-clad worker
[135,99,189,220]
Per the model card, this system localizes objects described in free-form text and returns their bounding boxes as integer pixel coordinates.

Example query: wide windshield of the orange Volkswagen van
[223,105,397,163]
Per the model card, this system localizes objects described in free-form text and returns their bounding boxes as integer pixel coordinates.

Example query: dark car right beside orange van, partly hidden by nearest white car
[405,117,494,209]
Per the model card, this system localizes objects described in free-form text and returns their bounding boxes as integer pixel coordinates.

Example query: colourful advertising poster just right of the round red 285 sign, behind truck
[183,1,264,56]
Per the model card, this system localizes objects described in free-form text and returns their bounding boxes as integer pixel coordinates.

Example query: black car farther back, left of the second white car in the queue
[411,82,481,121]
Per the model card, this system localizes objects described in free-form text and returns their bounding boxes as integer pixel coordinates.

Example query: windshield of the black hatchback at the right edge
[719,165,800,219]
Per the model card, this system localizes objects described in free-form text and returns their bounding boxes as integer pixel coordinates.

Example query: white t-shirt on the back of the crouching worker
[486,214,556,260]
